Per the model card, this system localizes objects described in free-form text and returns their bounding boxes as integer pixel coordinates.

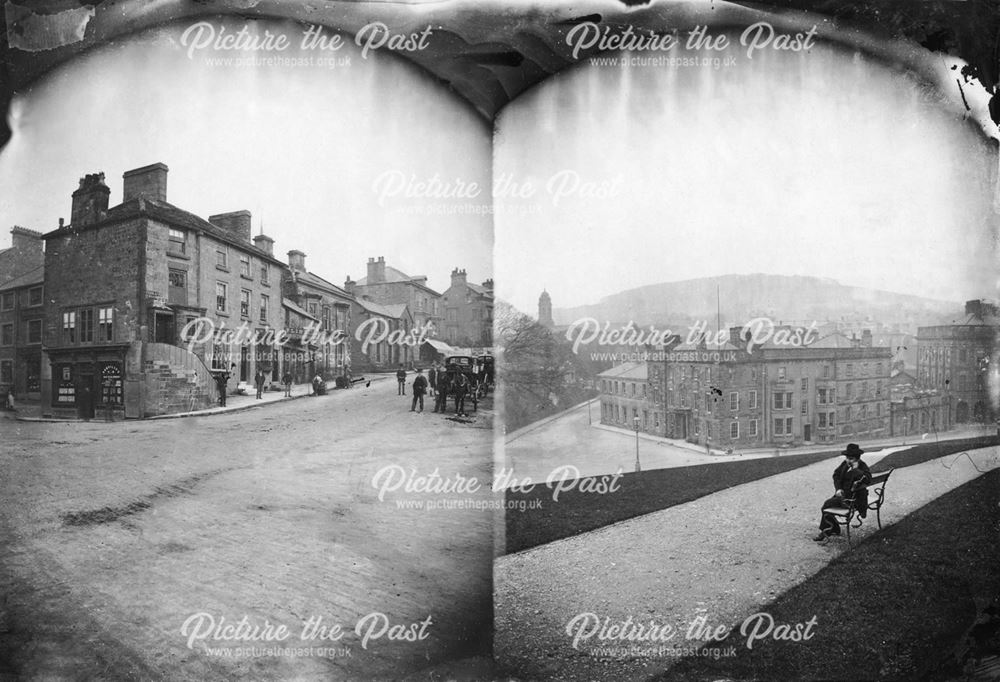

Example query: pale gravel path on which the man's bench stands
[494,447,1000,680]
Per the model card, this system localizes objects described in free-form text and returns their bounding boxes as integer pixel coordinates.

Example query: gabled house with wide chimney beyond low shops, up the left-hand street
[344,256,442,338]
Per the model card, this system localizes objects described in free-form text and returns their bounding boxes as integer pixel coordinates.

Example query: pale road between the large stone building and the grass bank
[504,401,996,481]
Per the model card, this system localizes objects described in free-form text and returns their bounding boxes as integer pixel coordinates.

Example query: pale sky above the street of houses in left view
[0,19,493,292]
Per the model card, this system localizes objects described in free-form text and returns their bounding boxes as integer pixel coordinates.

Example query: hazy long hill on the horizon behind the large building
[552,274,964,328]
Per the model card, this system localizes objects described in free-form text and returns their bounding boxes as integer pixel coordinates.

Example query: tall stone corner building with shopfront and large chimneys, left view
[40,163,283,418]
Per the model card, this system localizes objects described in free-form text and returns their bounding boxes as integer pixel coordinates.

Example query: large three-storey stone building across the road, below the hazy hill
[600,328,892,450]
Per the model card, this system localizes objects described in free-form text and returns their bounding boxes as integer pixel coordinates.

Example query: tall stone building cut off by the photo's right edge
[917,300,1000,424]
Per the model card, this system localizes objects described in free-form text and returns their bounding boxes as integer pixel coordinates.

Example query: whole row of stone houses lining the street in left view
[0,163,492,418]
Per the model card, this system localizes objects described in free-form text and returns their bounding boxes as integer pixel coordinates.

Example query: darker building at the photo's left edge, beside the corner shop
[0,226,45,400]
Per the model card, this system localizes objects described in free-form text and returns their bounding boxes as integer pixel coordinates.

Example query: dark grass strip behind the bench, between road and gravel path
[506,437,1000,554]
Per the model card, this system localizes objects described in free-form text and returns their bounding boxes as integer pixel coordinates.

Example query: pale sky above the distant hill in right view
[494,34,1000,313]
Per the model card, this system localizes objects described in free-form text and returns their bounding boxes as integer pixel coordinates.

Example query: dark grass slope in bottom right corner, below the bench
[654,471,1000,682]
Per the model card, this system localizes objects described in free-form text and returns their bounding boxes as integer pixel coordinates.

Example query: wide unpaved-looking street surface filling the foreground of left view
[0,380,495,679]
